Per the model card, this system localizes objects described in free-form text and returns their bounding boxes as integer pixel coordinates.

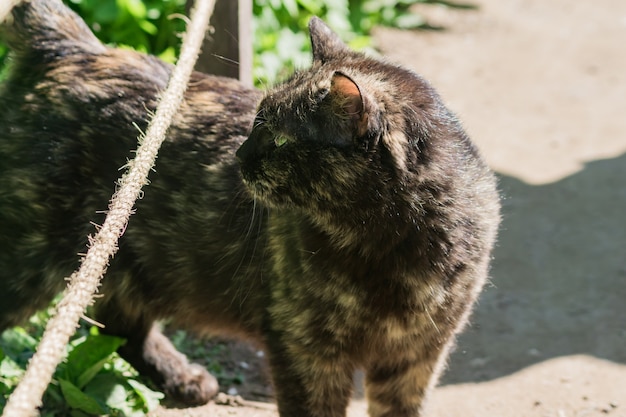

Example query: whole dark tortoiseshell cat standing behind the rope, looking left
[0,0,499,417]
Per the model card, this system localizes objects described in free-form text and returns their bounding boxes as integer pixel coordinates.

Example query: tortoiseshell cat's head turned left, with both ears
[237,18,449,221]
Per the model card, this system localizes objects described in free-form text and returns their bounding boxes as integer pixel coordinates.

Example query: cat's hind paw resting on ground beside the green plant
[163,363,219,406]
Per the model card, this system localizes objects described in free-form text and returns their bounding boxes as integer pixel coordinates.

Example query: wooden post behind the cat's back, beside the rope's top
[188,0,252,86]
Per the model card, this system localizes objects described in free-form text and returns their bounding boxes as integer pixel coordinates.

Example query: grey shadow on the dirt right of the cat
[441,154,626,385]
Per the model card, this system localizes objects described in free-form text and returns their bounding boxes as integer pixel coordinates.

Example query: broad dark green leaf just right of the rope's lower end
[66,334,125,388]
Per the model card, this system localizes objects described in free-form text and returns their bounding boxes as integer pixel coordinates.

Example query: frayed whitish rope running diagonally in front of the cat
[0,0,215,417]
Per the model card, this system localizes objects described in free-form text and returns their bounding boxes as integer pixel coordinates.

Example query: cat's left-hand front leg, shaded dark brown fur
[267,334,354,417]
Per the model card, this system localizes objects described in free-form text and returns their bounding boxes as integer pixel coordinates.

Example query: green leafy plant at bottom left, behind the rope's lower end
[0,313,163,417]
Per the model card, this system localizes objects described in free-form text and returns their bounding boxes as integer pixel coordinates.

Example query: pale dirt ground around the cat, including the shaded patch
[155,0,626,417]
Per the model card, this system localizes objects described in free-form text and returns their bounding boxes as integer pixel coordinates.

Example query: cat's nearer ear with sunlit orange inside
[330,72,369,137]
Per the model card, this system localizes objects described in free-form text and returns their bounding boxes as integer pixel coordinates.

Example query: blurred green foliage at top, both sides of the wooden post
[0,0,471,84]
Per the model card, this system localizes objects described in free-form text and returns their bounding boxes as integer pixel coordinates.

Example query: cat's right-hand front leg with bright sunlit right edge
[365,348,446,417]
